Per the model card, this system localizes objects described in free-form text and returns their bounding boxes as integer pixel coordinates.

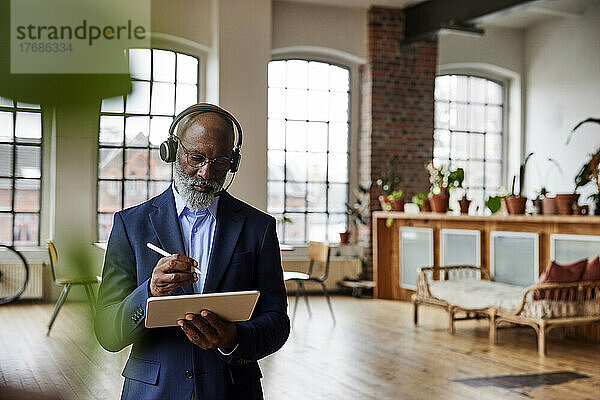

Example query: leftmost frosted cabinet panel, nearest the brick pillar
[400,227,433,290]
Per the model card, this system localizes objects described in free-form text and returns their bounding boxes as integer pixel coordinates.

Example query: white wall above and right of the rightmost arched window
[438,26,525,189]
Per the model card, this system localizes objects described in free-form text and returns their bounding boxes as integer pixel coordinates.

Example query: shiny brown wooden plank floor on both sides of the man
[0,297,600,400]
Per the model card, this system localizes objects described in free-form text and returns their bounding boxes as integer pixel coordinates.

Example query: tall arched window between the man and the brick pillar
[267,59,351,243]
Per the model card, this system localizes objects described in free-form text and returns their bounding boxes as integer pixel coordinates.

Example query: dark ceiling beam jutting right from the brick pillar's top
[404,0,544,42]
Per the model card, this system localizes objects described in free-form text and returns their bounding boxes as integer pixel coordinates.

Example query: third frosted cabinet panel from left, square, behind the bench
[490,232,539,286]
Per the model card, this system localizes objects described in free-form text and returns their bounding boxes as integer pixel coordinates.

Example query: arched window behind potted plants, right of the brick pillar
[433,75,504,213]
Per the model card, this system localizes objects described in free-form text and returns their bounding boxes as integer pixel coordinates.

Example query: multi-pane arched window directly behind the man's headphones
[97,49,199,241]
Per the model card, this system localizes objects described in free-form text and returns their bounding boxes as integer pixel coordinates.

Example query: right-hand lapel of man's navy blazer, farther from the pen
[204,192,246,293]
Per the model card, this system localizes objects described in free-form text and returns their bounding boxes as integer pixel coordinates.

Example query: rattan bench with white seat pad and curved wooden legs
[412,266,600,355]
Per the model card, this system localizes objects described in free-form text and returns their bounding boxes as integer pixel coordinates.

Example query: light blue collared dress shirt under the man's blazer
[173,185,219,293]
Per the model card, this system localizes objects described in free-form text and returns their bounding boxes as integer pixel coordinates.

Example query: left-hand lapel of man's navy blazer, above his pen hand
[149,186,194,295]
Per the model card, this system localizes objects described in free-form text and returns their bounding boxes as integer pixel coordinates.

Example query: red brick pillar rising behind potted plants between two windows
[359,7,437,272]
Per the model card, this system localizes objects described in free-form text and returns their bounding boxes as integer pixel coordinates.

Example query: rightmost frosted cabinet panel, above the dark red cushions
[550,234,600,264]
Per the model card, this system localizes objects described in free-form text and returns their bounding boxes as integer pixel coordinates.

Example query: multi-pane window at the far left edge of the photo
[0,97,42,246]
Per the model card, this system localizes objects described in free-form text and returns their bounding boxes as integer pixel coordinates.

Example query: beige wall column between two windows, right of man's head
[214,0,271,210]
